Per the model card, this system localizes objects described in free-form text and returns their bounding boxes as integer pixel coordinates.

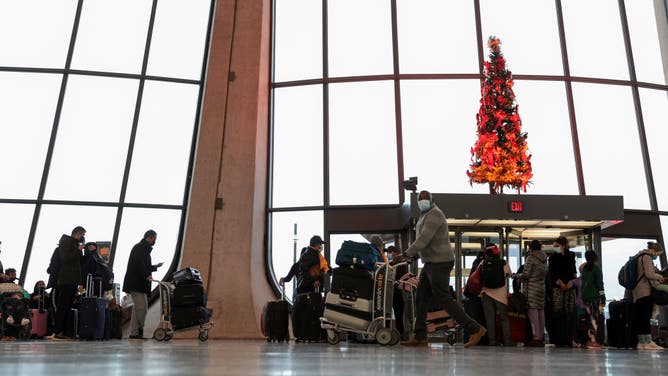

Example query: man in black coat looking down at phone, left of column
[123,230,162,339]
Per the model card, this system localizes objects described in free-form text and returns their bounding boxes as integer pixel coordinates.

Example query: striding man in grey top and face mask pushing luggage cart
[401,191,487,348]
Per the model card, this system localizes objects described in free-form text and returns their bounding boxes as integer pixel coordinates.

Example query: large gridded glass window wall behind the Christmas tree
[268,0,668,295]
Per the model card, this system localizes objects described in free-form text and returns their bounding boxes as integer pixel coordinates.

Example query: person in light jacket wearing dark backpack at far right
[633,242,664,350]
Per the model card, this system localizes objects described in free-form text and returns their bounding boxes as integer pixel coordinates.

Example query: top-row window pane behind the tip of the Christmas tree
[480,0,564,75]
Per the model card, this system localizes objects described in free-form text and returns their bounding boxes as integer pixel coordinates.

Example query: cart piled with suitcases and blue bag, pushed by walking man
[321,241,401,345]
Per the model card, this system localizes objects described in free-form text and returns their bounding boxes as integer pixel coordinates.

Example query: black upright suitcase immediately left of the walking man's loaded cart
[292,292,324,342]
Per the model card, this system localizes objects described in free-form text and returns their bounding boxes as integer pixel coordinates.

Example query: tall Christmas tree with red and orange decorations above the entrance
[466,36,533,193]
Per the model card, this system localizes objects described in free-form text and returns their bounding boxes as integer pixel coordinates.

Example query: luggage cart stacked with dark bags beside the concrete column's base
[153,268,213,342]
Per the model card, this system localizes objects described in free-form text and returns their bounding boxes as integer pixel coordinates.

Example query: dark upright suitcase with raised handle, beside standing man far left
[79,274,107,339]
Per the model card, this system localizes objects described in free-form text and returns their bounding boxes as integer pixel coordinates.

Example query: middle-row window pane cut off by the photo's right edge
[640,89,668,212]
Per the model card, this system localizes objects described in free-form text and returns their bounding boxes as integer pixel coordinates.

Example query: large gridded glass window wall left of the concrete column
[0,0,214,291]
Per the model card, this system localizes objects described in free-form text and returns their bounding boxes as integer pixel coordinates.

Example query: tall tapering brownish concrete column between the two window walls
[180,0,273,338]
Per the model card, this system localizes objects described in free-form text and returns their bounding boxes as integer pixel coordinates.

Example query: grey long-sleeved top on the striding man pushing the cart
[406,204,455,263]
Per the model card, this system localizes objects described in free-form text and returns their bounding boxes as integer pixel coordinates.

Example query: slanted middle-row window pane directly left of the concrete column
[125,81,199,205]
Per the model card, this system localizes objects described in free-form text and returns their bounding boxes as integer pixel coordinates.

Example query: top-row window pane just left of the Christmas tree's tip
[397,0,478,73]
